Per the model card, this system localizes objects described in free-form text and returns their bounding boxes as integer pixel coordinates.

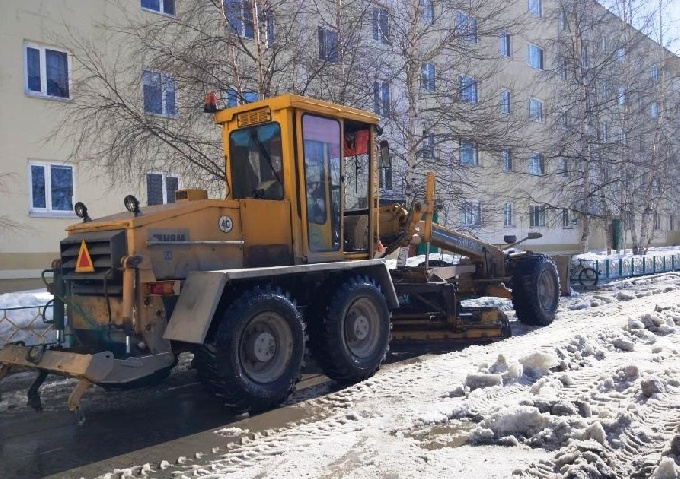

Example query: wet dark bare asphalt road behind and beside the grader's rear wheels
[0,371,335,479]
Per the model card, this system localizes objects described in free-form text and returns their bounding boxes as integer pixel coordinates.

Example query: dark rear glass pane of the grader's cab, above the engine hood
[229,123,283,200]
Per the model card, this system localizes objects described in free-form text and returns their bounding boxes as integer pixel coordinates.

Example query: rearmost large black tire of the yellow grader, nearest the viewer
[196,287,306,412]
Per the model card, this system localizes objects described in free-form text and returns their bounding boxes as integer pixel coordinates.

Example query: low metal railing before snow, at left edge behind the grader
[0,303,56,349]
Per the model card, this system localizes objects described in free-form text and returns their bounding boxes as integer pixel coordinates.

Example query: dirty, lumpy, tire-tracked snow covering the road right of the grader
[0,256,680,479]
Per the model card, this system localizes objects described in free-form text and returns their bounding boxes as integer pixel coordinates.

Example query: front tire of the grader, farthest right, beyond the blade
[512,254,560,326]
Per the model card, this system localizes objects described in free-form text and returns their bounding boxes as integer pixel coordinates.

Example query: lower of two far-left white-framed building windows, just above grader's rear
[28,161,73,216]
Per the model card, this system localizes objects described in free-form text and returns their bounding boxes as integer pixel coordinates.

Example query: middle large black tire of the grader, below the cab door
[308,276,390,383]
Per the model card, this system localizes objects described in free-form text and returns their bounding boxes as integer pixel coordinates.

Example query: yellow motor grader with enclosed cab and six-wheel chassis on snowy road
[0,95,560,411]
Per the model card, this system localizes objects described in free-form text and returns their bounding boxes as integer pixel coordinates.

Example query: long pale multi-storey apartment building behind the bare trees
[0,0,680,291]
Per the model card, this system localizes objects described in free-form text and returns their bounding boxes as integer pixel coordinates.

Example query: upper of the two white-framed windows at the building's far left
[24,44,71,98]
